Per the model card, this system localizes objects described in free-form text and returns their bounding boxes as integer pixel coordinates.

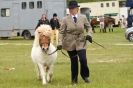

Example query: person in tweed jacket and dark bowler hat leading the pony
[57,1,93,84]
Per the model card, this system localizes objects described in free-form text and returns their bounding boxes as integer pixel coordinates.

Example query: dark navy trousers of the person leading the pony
[67,49,89,82]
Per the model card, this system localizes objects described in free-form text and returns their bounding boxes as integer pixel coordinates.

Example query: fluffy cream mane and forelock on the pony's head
[34,25,52,46]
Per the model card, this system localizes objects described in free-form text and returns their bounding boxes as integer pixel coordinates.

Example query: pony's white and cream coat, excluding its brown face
[31,25,57,85]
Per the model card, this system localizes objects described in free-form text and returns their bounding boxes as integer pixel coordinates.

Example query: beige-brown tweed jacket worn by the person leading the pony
[59,14,91,51]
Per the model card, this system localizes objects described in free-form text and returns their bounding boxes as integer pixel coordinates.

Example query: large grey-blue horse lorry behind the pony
[0,0,67,39]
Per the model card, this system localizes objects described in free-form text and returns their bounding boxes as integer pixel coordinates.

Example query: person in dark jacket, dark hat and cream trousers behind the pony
[50,13,60,44]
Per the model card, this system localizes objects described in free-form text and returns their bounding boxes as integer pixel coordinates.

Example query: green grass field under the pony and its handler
[0,28,133,88]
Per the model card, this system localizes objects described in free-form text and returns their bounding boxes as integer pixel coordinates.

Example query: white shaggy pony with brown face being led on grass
[31,25,57,85]
